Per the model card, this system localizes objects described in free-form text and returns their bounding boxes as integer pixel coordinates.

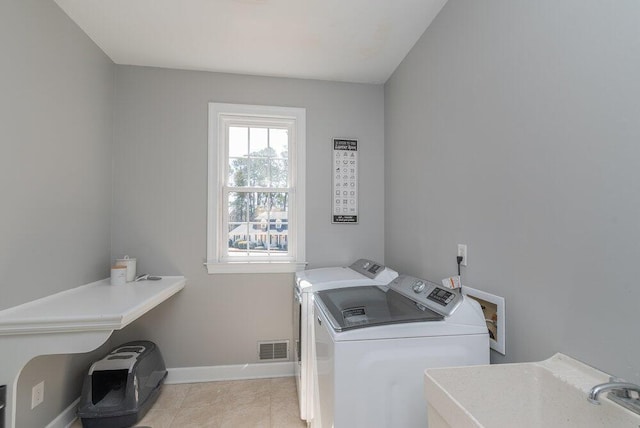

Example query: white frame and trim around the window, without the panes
[205,103,306,274]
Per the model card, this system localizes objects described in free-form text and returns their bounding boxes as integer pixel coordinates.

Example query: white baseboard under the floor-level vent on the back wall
[165,361,295,384]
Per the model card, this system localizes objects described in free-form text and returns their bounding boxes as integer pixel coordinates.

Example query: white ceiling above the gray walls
[55,0,447,83]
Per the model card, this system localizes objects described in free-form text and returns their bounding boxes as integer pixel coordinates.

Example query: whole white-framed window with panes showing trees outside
[206,103,305,273]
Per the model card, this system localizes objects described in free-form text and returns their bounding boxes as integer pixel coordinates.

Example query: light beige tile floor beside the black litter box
[71,377,307,428]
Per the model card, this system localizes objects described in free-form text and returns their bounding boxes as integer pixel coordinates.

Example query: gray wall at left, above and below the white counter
[0,0,114,427]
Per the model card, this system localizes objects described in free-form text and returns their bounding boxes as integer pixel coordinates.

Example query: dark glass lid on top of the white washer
[316,286,444,331]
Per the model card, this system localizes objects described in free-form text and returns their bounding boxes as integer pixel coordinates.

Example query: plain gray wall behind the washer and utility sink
[385,0,640,381]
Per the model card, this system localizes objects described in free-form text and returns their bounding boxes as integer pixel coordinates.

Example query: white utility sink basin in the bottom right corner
[425,354,640,428]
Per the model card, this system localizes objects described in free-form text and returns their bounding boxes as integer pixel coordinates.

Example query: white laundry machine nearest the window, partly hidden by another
[293,259,398,422]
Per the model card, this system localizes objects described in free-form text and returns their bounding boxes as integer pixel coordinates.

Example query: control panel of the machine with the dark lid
[389,275,464,317]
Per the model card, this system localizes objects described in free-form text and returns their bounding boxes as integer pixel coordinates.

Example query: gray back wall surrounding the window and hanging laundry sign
[111,66,384,367]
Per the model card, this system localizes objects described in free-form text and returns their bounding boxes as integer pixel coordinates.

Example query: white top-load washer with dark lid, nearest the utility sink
[313,275,489,428]
